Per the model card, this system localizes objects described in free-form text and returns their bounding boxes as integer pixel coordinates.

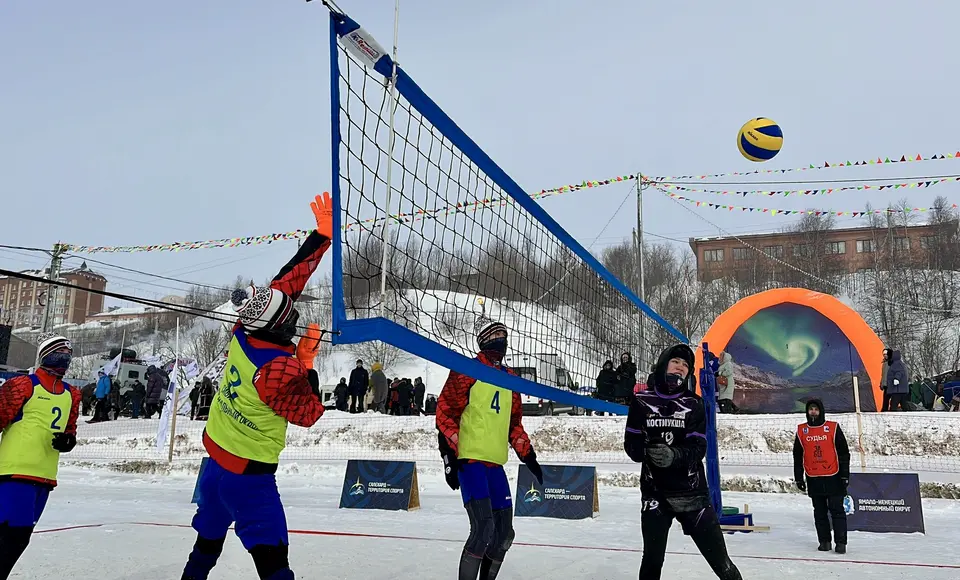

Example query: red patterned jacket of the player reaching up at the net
[203,231,330,473]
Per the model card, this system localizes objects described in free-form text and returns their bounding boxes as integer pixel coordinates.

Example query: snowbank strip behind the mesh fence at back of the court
[69,410,960,481]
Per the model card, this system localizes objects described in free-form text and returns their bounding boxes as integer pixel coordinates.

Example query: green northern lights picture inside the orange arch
[724,302,873,413]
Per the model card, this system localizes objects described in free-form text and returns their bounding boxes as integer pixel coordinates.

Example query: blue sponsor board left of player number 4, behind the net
[340,459,420,510]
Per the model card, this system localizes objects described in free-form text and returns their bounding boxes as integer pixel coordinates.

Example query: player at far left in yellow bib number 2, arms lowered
[0,334,80,580]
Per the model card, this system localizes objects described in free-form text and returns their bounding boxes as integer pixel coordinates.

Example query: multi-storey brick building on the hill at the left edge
[0,262,107,328]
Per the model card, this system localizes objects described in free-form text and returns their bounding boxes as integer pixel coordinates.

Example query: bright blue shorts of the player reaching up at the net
[192,458,290,551]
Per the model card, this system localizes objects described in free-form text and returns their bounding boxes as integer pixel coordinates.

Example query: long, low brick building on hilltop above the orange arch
[690,222,960,281]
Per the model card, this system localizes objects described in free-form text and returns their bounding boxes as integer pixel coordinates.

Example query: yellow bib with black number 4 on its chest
[458,381,513,465]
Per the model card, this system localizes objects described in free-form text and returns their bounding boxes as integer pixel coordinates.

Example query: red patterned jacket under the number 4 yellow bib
[437,352,533,460]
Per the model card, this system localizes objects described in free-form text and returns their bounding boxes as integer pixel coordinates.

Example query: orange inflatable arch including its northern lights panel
[696,288,884,413]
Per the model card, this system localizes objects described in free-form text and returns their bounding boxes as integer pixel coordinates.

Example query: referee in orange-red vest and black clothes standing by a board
[793,399,850,554]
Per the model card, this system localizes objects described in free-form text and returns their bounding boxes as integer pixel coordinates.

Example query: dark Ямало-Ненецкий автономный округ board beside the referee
[843,473,925,534]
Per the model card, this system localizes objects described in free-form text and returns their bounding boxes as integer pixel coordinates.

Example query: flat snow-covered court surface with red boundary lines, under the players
[11,462,960,580]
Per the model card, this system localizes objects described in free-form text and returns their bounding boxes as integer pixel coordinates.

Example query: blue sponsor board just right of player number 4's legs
[513,465,600,520]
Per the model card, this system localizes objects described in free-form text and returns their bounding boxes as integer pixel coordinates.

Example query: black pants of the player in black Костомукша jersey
[640,503,741,580]
